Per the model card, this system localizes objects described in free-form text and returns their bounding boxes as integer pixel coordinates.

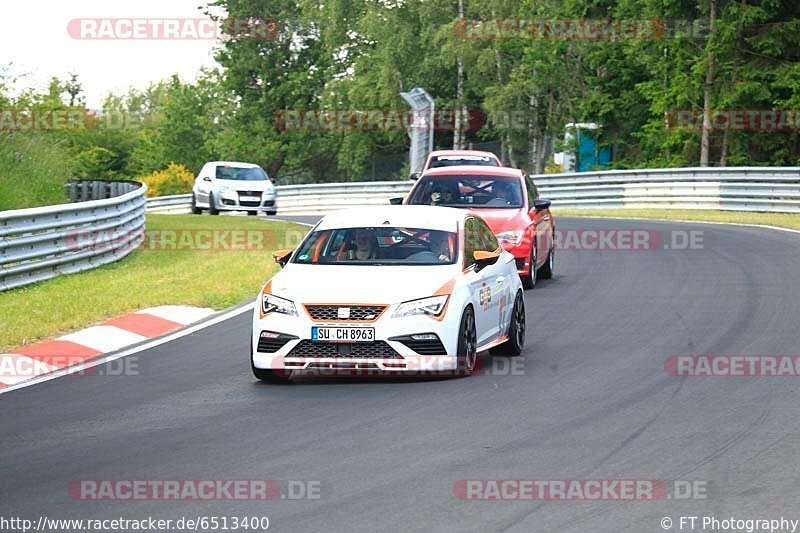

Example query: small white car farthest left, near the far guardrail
[192,161,278,215]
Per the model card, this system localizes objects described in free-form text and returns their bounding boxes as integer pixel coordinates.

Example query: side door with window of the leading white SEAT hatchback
[464,217,505,345]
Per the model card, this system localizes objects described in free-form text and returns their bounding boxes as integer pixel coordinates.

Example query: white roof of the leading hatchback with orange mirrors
[316,205,469,232]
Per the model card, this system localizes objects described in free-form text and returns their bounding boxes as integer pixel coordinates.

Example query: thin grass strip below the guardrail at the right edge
[553,208,800,229]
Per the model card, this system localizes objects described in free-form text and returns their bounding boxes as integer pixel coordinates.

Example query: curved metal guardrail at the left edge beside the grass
[0,181,146,291]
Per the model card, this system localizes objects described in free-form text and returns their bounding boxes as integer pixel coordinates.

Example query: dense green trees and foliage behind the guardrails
[0,0,800,210]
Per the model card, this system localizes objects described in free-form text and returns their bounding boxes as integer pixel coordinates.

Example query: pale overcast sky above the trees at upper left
[0,0,223,109]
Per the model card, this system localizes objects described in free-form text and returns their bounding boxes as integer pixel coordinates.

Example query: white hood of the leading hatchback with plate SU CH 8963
[270,263,461,304]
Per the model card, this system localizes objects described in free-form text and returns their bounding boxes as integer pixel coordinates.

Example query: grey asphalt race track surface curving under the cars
[0,218,800,532]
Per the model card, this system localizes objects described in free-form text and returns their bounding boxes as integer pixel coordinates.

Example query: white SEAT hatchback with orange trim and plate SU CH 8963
[250,206,525,381]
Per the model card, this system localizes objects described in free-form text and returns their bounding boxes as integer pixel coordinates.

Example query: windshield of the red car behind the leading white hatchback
[409,175,522,209]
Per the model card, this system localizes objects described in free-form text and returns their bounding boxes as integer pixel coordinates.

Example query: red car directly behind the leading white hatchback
[403,165,555,289]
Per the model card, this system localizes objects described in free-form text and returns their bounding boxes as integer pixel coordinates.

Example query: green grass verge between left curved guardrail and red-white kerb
[0,215,308,352]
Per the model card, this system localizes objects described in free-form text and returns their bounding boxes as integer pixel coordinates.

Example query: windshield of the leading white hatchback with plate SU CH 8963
[293,226,458,266]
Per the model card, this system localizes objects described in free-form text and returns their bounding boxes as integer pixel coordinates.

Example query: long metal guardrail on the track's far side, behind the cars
[147,167,800,215]
